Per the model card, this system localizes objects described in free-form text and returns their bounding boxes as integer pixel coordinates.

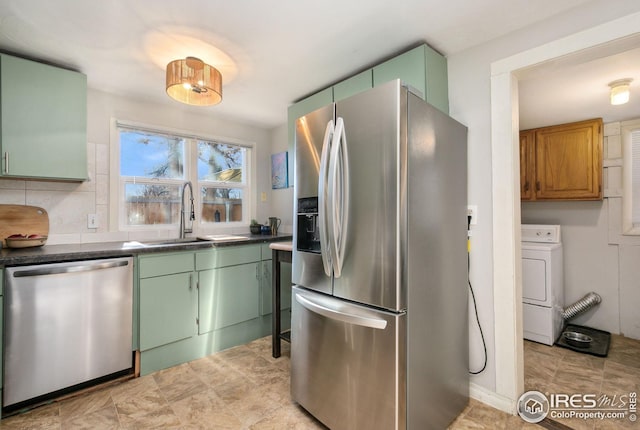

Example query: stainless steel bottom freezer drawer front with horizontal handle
[291,287,406,430]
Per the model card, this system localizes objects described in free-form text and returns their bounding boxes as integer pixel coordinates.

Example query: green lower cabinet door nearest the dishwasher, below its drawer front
[140,273,196,351]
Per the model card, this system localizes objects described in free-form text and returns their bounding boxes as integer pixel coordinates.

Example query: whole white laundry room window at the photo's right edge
[620,119,640,235]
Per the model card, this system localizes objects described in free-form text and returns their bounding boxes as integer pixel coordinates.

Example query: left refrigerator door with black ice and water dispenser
[291,104,334,294]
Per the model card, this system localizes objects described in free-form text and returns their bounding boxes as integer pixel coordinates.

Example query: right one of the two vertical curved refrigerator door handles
[329,117,349,278]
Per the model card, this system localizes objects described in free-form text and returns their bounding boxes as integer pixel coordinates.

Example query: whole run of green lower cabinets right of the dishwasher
[139,244,271,375]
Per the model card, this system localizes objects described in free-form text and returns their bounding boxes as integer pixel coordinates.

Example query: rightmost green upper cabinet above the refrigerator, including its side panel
[373,45,449,114]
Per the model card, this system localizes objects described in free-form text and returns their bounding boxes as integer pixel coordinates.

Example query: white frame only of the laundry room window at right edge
[620,118,640,236]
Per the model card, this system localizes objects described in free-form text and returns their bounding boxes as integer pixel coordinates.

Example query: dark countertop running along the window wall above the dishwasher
[0,234,292,267]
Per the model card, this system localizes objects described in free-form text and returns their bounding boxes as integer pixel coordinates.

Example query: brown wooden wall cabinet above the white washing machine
[520,118,602,201]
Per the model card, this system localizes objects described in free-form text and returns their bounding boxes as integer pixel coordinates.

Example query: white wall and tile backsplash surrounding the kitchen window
[0,89,272,244]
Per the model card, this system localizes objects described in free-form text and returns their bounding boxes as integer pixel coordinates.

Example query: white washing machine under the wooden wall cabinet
[522,224,564,345]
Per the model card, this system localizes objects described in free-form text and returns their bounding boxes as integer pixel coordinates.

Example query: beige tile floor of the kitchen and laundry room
[0,336,640,430]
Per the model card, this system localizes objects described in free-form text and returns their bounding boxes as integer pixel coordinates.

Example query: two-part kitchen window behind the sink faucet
[112,122,251,230]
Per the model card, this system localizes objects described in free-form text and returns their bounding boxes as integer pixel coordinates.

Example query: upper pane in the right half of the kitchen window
[198,141,246,183]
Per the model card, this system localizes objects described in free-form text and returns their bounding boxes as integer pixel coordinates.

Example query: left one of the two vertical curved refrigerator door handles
[318,120,334,276]
